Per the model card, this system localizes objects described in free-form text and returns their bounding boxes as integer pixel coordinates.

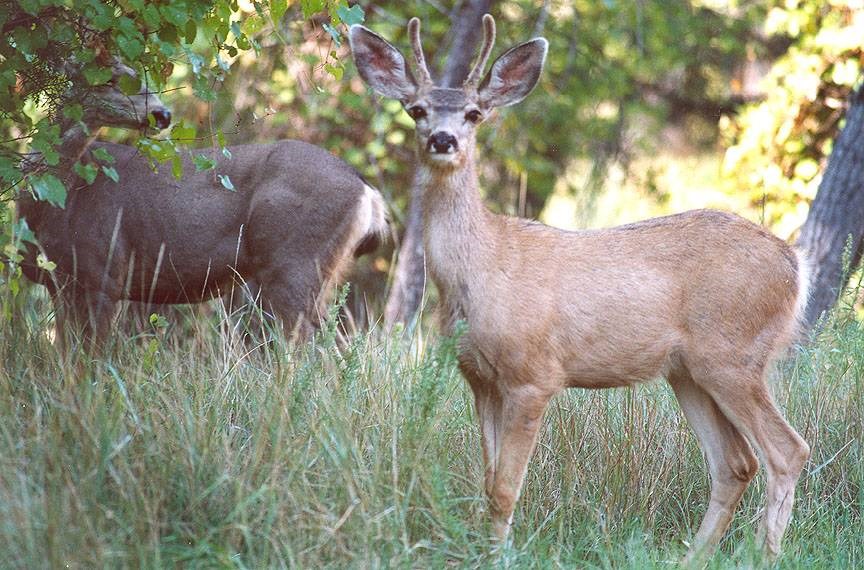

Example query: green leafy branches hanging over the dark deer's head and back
[0,0,364,298]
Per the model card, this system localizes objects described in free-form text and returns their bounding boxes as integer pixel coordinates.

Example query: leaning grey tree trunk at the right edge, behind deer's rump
[797,84,864,329]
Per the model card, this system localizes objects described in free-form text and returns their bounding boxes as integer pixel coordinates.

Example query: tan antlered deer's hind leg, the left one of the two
[669,369,759,566]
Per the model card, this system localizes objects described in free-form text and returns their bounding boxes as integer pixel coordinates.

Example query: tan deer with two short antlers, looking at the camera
[349,14,810,565]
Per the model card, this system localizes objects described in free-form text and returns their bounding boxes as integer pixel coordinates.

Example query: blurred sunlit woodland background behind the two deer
[3,0,864,326]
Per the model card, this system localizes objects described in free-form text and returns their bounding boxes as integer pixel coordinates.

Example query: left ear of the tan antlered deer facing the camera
[348,24,417,101]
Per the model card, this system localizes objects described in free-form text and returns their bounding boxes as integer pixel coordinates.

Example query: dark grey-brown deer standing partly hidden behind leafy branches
[17,56,387,352]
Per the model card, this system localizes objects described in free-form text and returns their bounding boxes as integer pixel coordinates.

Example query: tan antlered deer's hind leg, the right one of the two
[705,371,810,558]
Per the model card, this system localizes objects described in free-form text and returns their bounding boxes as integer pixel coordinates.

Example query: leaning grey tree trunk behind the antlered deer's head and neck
[384,0,492,328]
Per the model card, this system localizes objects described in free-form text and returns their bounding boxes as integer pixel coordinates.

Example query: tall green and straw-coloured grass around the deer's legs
[0,290,864,568]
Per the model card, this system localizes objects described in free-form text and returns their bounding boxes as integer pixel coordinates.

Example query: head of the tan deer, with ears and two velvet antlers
[349,14,548,168]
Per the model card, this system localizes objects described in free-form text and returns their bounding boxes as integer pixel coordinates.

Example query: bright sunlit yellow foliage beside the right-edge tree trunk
[723,0,864,233]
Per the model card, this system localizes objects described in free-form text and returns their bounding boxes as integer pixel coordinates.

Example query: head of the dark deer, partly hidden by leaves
[68,59,171,130]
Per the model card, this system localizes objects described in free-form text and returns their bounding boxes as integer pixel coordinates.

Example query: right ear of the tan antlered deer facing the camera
[478,38,549,108]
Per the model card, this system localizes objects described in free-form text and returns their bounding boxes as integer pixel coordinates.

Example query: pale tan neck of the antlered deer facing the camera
[416,153,495,319]
